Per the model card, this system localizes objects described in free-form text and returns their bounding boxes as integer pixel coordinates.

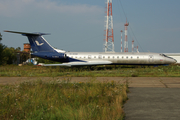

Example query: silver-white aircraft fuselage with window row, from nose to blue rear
[66,52,176,64]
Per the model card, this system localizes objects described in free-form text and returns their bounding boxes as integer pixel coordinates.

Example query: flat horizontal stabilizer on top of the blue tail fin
[4,30,50,36]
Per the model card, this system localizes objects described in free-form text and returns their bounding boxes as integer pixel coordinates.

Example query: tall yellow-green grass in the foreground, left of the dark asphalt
[0,79,128,120]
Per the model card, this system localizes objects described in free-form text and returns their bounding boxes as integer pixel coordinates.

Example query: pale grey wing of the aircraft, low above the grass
[42,61,112,67]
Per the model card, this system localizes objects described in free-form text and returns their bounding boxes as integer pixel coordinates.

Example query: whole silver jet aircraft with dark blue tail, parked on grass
[4,31,177,67]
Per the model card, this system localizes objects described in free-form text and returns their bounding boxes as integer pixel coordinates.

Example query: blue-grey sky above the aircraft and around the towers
[0,0,180,53]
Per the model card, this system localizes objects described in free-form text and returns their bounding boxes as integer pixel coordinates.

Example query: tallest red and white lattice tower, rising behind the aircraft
[105,0,114,52]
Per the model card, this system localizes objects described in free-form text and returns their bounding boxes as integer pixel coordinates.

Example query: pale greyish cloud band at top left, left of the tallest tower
[0,0,104,17]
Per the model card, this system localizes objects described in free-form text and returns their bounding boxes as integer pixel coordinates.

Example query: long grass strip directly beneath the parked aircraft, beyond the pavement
[0,65,180,77]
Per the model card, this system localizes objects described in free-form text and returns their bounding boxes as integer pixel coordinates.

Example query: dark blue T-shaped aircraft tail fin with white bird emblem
[4,31,55,52]
